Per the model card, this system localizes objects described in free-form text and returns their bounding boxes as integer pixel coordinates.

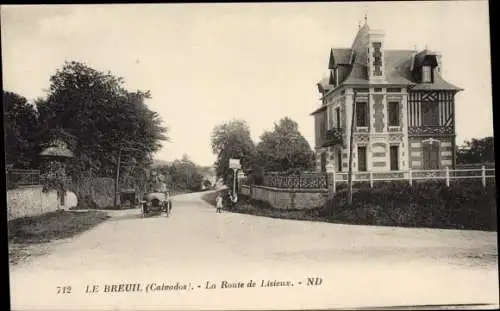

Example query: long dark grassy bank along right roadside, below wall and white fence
[203,181,497,231]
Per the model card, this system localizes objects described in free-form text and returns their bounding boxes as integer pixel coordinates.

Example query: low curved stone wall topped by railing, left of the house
[240,185,328,210]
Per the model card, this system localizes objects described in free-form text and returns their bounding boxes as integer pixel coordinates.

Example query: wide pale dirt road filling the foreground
[10,194,499,310]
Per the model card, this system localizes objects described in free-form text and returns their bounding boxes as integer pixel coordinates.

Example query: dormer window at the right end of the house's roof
[410,49,441,83]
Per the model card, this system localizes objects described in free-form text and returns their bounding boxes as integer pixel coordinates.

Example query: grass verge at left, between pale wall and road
[7,211,109,264]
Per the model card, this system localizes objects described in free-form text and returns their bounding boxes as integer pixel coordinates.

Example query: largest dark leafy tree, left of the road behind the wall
[37,62,168,176]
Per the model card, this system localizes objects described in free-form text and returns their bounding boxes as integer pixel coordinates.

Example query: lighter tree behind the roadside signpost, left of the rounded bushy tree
[211,120,257,185]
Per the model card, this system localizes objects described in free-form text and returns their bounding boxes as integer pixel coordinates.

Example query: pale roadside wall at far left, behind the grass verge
[7,186,77,220]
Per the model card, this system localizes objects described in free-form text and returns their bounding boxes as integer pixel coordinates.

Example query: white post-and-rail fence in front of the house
[332,166,495,191]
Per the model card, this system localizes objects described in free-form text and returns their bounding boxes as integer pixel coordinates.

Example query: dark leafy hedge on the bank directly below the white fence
[327,180,497,230]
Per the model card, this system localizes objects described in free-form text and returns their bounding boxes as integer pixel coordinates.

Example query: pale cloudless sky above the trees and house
[1,1,493,165]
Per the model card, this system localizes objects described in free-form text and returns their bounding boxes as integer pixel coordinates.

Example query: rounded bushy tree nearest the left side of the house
[257,117,314,173]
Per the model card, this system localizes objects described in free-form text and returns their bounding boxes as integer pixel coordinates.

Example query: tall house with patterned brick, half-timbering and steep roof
[311,19,462,176]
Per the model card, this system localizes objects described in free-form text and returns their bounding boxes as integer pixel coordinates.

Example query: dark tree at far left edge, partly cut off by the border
[3,92,41,169]
